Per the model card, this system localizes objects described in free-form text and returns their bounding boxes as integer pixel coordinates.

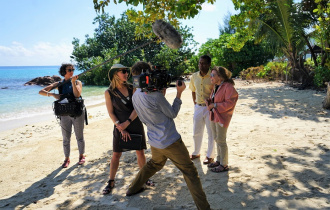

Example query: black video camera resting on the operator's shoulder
[133,66,172,92]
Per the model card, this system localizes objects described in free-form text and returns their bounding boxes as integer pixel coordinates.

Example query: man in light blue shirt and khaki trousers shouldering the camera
[126,61,210,210]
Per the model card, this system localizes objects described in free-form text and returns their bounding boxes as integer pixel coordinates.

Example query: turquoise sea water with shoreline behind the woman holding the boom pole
[0,66,107,122]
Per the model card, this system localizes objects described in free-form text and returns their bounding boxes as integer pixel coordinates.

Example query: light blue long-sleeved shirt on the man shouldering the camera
[132,88,182,149]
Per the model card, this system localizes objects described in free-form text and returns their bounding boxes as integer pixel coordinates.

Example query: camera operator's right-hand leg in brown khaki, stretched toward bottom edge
[164,139,210,210]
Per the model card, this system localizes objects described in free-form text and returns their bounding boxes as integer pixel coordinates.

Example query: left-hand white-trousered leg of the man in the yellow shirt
[191,105,205,155]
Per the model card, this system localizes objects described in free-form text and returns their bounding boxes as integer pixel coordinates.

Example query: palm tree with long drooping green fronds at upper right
[250,0,308,82]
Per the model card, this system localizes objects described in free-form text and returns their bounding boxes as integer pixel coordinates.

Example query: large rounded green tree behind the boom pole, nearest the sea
[71,13,196,85]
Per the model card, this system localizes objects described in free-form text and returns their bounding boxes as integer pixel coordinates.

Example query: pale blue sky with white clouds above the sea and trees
[0,0,235,66]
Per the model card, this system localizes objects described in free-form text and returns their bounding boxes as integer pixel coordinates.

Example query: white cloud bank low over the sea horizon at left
[0,42,73,66]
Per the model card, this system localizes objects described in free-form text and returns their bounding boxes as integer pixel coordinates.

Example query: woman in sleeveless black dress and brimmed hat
[103,64,153,194]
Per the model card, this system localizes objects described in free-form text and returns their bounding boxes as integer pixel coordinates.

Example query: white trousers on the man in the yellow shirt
[192,105,215,158]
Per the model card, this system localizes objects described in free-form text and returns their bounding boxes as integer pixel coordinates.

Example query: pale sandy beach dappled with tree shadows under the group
[0,80,330,210]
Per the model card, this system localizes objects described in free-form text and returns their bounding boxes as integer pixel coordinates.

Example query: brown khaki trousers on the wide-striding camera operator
[128,138,210,210]
